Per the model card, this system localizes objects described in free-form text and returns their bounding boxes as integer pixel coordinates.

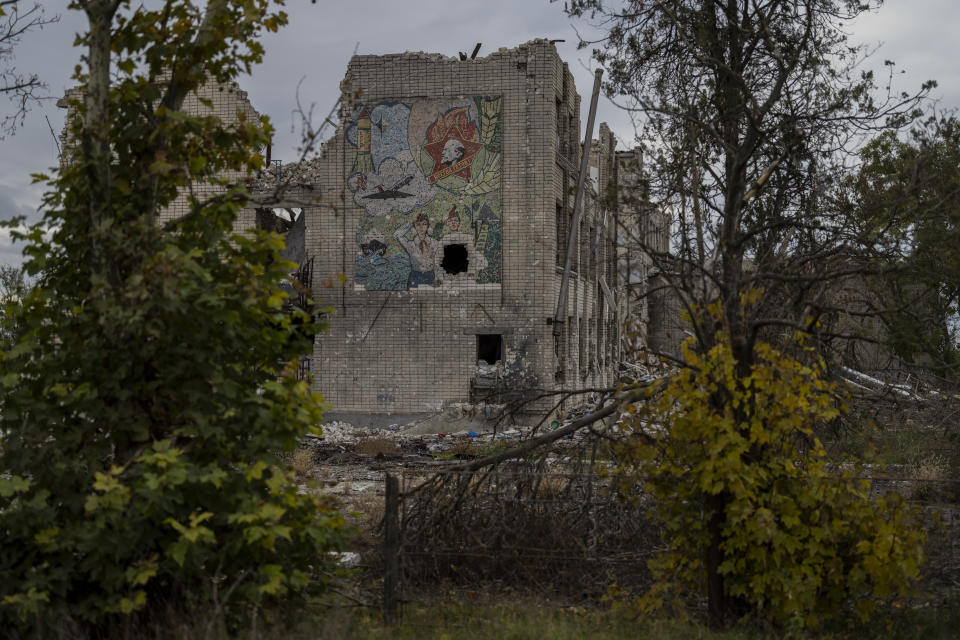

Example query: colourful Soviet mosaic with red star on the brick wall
[347,97,503,291]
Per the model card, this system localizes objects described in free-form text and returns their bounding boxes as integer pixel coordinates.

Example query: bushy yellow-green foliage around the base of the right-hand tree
[618,336,923,627]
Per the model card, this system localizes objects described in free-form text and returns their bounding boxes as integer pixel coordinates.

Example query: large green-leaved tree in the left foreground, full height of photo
[0,0,344,635]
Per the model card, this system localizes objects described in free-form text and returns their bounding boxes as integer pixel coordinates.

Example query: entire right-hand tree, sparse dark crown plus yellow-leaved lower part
[564,0,936,626]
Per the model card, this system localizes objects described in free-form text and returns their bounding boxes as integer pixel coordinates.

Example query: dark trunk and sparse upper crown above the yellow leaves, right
[566,0,932,624]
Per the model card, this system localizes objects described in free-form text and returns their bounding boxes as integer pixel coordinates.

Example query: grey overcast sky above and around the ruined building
[0,0,960,264]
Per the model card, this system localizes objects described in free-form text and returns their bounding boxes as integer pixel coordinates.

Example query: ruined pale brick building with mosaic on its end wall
[288,40,625,422]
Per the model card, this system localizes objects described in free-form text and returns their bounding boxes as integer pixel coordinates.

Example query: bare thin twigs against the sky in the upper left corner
[0,0,59,135]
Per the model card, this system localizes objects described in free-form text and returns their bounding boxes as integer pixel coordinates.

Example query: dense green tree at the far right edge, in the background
[848,116,960,381]
